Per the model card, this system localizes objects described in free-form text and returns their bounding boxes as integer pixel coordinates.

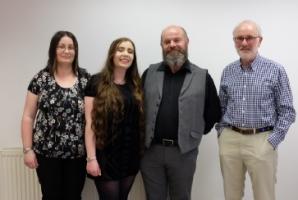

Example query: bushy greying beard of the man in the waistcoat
[163,50,187,67]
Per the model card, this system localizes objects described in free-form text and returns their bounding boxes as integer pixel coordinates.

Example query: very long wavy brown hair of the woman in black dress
[92,37,144,152]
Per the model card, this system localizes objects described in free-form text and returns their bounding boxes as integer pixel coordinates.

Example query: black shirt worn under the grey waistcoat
[142,61,221,140]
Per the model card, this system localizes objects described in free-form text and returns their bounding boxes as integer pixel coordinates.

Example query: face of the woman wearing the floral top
[56,36,75,65]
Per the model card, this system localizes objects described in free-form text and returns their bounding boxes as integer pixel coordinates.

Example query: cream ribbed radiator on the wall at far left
[0,148,41,200]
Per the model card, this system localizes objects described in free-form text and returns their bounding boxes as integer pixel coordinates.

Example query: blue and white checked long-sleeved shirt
[216,55,296,148]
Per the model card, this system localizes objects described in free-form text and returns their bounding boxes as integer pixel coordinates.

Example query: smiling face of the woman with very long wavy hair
[113,41,135,70]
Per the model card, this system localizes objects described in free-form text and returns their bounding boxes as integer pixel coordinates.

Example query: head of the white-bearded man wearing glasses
[233,21,262,66]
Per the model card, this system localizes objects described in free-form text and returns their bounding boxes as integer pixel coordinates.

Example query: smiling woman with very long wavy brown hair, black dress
[85,38,144,200]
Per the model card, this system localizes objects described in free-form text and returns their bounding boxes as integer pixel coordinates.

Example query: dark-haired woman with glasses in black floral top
[22,31,90,200]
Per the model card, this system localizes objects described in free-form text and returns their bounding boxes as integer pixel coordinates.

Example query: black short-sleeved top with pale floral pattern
[28,68,90,159]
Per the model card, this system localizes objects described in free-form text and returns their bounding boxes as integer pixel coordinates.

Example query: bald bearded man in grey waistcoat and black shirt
[141,26,220,200]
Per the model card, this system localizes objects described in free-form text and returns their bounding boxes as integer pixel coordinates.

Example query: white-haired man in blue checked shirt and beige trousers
[216,20,295,200]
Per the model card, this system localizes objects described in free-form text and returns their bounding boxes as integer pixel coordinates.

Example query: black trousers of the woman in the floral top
[36,155,86,200]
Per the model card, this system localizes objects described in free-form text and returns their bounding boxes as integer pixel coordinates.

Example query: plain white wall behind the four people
[0,0,298,200]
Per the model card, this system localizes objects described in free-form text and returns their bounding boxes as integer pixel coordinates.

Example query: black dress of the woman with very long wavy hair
[85,74,140,180]
